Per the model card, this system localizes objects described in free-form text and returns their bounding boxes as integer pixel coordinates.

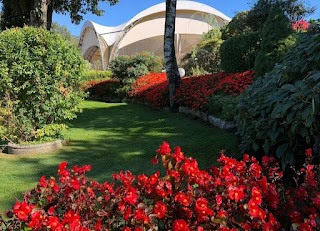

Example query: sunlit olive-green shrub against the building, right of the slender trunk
[181,29,222,76]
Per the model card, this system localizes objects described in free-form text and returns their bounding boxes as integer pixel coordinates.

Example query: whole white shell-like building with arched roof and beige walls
[79,1,231,69]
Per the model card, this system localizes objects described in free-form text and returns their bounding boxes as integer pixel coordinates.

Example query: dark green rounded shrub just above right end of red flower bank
[220,32,261,73]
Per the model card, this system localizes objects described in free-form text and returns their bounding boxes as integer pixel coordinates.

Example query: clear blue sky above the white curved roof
[45,0,320,36]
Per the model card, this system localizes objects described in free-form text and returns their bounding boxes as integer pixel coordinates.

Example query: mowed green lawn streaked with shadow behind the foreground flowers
[0,101,238,211]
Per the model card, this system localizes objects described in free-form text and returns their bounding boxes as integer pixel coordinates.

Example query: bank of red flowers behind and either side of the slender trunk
[129,71,254,110]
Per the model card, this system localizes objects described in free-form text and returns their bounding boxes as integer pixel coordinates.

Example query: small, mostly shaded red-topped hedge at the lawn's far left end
[82,79,121,100]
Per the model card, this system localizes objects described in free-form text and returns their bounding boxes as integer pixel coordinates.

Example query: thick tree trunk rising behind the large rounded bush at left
[30,0,50,28]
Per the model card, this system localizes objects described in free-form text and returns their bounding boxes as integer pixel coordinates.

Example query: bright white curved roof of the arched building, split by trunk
[79,0,231,46]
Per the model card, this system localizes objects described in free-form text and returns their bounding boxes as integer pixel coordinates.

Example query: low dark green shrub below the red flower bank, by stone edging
[206,95,239,121]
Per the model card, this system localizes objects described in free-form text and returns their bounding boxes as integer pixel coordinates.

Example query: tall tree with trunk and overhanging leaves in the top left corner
[0,0,118,30]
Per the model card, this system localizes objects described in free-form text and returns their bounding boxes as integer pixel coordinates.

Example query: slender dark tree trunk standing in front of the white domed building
[164,0,181,112]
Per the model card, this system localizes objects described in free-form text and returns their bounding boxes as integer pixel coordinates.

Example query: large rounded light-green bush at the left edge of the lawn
[0,27,85,142]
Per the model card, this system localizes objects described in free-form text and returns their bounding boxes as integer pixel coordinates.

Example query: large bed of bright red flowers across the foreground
[0,142,320,231]
